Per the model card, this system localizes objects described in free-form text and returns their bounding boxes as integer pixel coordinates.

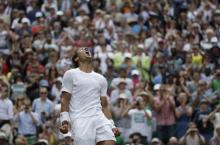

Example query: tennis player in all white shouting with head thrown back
[60,48,119,145]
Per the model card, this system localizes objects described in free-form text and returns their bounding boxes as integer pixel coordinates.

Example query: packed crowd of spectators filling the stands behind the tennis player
[0,0,220,145]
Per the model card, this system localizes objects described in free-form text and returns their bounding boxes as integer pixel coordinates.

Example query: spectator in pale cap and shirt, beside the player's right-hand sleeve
[110,79,132,105]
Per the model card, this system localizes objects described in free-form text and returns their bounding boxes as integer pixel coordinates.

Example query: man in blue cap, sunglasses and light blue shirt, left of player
[32,86,54,122]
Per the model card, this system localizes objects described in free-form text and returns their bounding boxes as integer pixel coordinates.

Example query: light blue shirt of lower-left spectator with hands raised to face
[18,111,40,135]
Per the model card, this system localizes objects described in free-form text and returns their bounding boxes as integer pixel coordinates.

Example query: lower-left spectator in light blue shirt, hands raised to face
[14,100,40,144]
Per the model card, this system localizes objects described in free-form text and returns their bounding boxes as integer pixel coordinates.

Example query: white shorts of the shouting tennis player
[71,115,116,145]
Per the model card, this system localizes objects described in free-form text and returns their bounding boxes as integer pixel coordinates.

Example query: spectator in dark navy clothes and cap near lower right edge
[193,99,213,141]
